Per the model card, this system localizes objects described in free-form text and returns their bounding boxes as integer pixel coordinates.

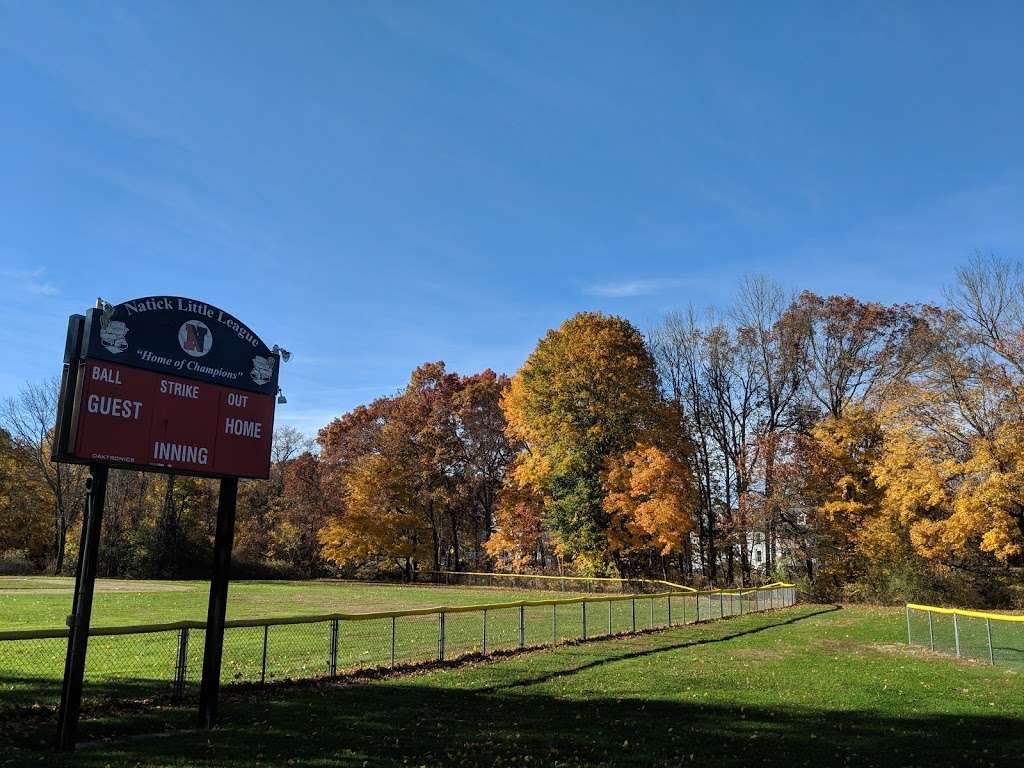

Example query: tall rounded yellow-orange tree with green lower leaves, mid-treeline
[502,312,662,572]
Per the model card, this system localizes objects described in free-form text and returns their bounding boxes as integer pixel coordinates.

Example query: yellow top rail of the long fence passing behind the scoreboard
[0,582,794,641]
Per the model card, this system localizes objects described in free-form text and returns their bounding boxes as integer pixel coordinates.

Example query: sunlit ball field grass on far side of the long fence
[0,579,593,719]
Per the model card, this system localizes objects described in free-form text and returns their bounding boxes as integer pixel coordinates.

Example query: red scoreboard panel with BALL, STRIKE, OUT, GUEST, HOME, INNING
[72,358,274,478]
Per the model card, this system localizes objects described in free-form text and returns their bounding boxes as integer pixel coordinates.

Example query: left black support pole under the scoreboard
[57,465,108,752]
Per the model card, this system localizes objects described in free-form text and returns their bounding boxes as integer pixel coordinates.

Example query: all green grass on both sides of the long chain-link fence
[0,582,1024,768]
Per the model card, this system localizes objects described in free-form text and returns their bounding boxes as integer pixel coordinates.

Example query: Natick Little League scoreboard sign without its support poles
[54,296,280,478]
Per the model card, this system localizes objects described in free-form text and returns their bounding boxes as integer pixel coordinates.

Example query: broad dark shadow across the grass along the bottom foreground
[29,684,1024,768]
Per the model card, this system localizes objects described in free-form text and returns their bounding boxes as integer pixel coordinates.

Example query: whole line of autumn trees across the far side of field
[6,258,1024,603]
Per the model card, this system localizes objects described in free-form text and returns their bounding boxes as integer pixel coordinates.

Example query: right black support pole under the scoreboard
[199,477,239,728]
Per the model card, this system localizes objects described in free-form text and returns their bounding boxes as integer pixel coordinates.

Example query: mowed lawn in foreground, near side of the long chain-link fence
[0,605,1024,768]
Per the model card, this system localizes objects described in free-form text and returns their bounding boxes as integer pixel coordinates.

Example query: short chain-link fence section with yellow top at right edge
[906,603,1024,666]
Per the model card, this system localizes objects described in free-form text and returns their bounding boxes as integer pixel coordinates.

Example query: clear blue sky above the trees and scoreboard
[0,0,1024,433]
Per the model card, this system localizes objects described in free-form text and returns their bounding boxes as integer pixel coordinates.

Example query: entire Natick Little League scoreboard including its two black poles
[51,296,289,750]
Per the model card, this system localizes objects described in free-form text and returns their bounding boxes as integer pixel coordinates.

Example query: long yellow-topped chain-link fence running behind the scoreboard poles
[0,584,797,715]
